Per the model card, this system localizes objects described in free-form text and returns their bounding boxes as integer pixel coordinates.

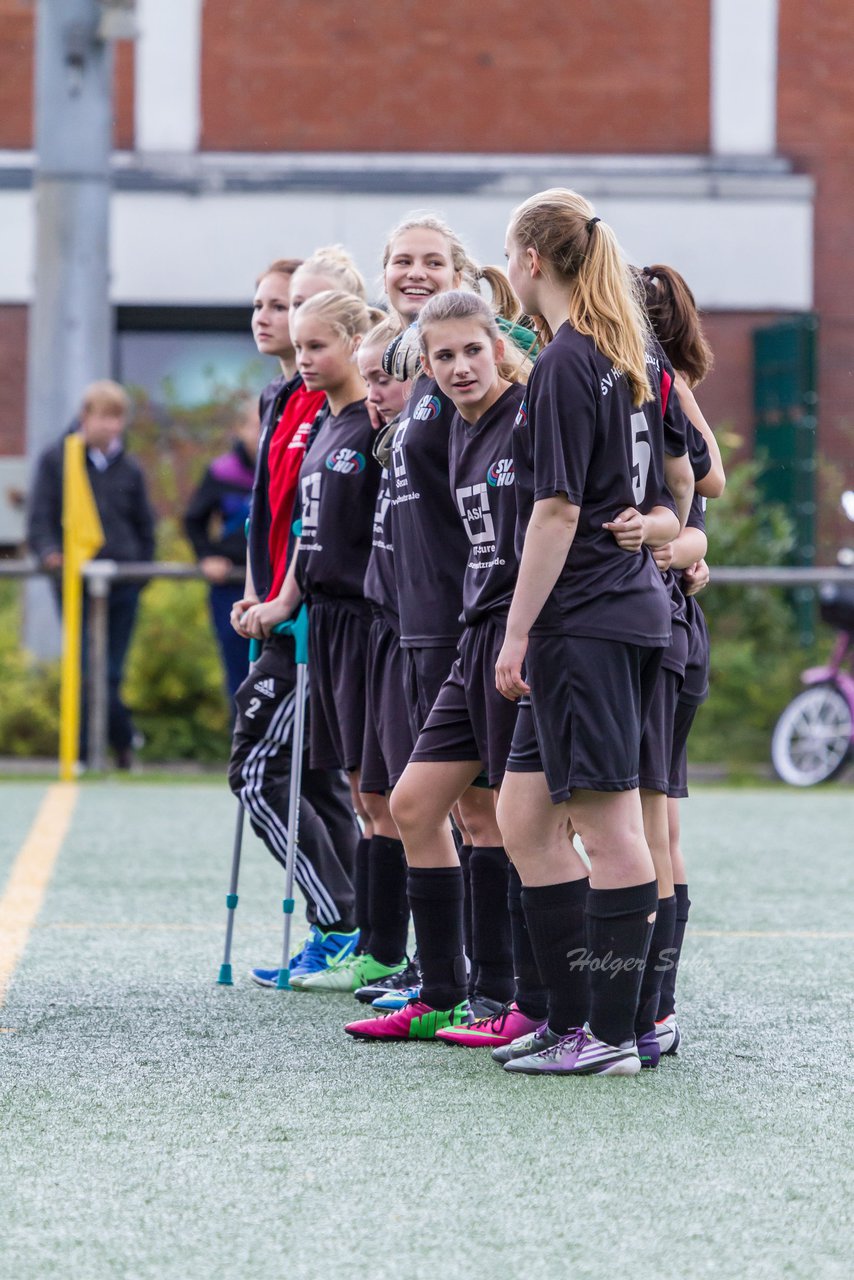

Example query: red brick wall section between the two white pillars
[202,0,709,152]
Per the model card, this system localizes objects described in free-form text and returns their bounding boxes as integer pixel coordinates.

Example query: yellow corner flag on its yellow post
[59,431,104,782]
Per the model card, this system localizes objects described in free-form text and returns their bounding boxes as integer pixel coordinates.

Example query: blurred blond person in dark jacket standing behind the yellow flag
[27,380,154,769]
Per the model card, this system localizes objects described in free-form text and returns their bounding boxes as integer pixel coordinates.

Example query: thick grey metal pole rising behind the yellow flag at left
[24,0,113,657]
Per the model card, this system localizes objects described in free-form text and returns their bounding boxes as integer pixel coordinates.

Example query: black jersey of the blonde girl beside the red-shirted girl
[297,401,380,599]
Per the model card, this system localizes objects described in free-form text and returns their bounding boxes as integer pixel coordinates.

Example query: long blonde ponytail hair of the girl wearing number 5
[510,187,653,406]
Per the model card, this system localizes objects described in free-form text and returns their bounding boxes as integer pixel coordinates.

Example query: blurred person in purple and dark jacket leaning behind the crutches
[184,398,261,705]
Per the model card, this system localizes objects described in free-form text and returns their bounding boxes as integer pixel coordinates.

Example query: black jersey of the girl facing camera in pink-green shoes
[448,387,525,626]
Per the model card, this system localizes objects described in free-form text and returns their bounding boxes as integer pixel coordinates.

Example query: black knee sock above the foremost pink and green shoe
[407,867,467,1009]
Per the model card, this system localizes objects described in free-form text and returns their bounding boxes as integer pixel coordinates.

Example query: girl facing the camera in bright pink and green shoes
[347,291,558,1046]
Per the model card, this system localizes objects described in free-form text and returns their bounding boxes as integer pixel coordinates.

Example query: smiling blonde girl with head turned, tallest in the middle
[383,215,519,1012]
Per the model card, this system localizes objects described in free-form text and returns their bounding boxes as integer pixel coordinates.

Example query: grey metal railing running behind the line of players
[0,557,854,772]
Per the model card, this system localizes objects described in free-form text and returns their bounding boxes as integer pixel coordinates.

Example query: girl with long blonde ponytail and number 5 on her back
[494,189,684,1075]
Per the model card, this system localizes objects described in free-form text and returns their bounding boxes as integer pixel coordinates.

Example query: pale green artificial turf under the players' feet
[0,782,854,1280]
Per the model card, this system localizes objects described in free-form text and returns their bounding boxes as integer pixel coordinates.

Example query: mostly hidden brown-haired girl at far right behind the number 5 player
[641,265,725,1053]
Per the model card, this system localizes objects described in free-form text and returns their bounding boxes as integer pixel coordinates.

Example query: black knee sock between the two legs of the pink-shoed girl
[469,845,513,1005]
